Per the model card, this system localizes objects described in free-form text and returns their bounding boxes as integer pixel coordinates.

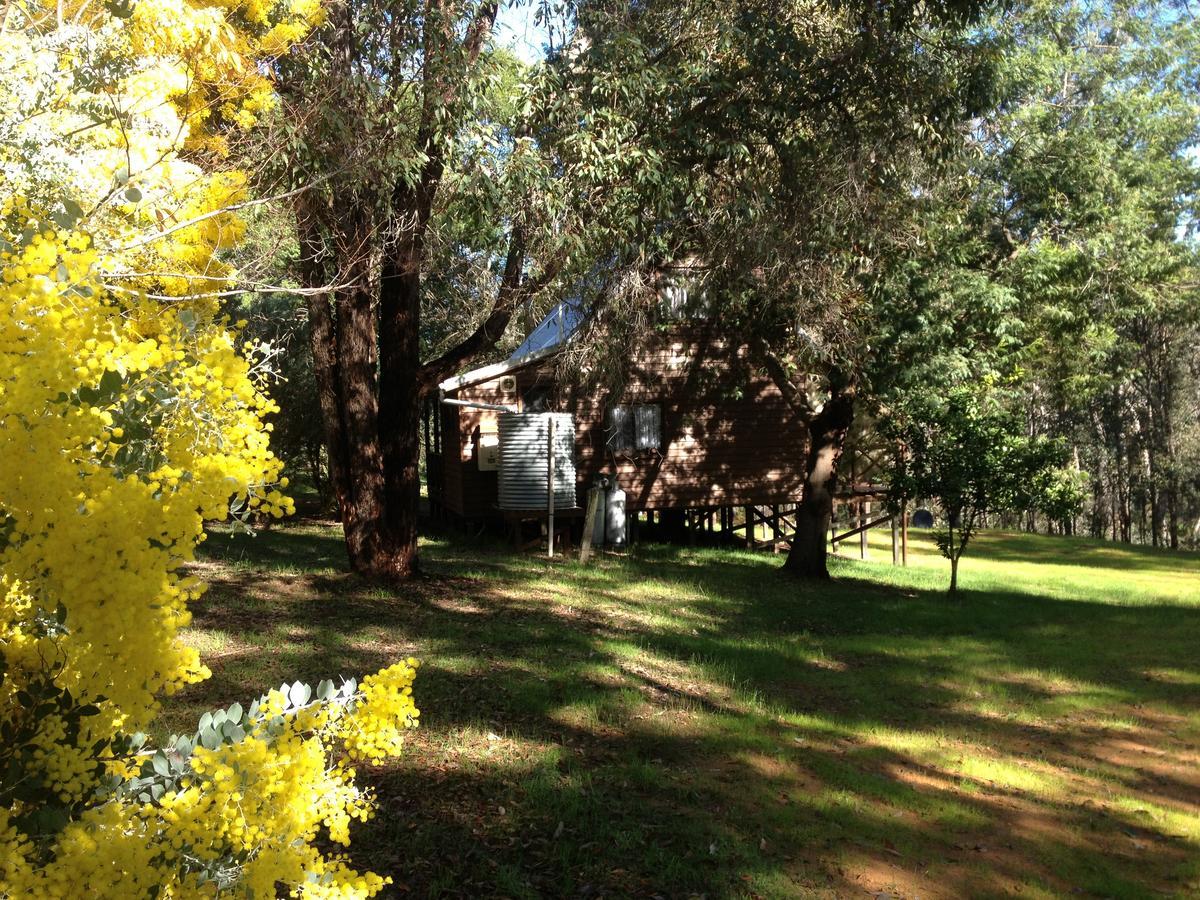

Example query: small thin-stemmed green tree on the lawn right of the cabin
[886,385,1081,594]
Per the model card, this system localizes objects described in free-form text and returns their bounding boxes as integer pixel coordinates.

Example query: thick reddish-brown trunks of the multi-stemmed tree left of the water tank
[288,2,516,581]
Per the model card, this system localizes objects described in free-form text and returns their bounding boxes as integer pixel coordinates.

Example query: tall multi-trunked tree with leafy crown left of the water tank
[266,0,657,578]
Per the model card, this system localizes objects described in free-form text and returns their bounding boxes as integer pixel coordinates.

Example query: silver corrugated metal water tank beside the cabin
[499,413,575,510]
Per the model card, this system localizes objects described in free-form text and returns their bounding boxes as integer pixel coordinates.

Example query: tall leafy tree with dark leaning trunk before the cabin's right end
[561,2,1003,577]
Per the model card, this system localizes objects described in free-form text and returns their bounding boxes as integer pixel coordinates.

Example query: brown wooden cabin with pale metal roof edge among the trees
[425,309,808,540]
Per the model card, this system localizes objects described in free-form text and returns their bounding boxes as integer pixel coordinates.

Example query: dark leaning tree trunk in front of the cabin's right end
[784,382,854,578]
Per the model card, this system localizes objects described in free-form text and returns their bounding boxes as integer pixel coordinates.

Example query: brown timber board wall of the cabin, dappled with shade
[442,328,808,517]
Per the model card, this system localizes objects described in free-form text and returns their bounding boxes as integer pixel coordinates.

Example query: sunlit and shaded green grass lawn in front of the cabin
[169,523,1200,898]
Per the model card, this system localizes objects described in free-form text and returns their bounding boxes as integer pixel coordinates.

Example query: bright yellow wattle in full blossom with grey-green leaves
[0,0,419,898]
